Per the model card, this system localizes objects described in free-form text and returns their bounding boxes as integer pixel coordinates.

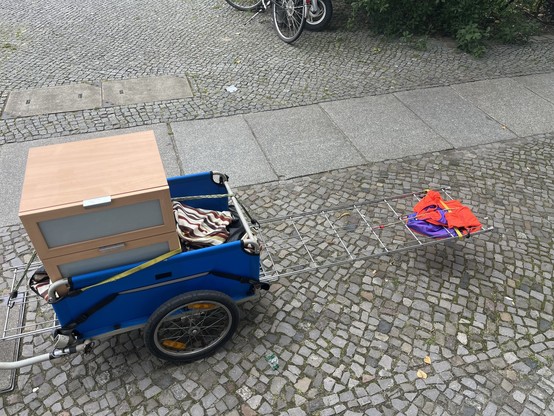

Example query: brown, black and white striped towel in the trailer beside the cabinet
[173,202,233,248]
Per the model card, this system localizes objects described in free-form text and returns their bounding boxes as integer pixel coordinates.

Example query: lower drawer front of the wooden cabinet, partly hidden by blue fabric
[43,233,179,281]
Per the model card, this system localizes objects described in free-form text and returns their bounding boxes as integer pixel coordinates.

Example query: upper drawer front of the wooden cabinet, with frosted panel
[21,189,175,260]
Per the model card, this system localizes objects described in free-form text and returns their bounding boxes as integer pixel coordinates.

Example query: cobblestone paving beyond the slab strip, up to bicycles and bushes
[0,0,554,144]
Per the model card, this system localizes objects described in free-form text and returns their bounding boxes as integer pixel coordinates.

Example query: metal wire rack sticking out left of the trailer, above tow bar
[0,262,60,341]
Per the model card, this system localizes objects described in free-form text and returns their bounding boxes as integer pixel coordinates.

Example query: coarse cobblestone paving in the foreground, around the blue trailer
[0,135,554,416]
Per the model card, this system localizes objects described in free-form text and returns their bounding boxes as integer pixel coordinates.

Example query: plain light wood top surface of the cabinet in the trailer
[19,131,167,214]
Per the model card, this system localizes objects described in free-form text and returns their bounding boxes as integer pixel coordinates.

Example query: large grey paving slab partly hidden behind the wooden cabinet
[0,124,181,226]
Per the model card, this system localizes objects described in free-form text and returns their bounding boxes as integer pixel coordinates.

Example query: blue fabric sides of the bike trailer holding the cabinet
[52,172,260,339]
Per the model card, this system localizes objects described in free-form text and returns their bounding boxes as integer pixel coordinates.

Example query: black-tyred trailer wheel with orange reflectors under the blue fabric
[144,290,239,363]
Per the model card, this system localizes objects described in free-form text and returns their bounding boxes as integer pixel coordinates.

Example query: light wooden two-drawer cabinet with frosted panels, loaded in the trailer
[19,131,179,280]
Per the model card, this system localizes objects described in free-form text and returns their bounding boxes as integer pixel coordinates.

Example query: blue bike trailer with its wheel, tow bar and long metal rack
[0,172,494,369]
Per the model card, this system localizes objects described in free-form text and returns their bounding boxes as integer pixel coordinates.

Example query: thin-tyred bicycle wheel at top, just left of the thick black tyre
[273,0,306,43]
